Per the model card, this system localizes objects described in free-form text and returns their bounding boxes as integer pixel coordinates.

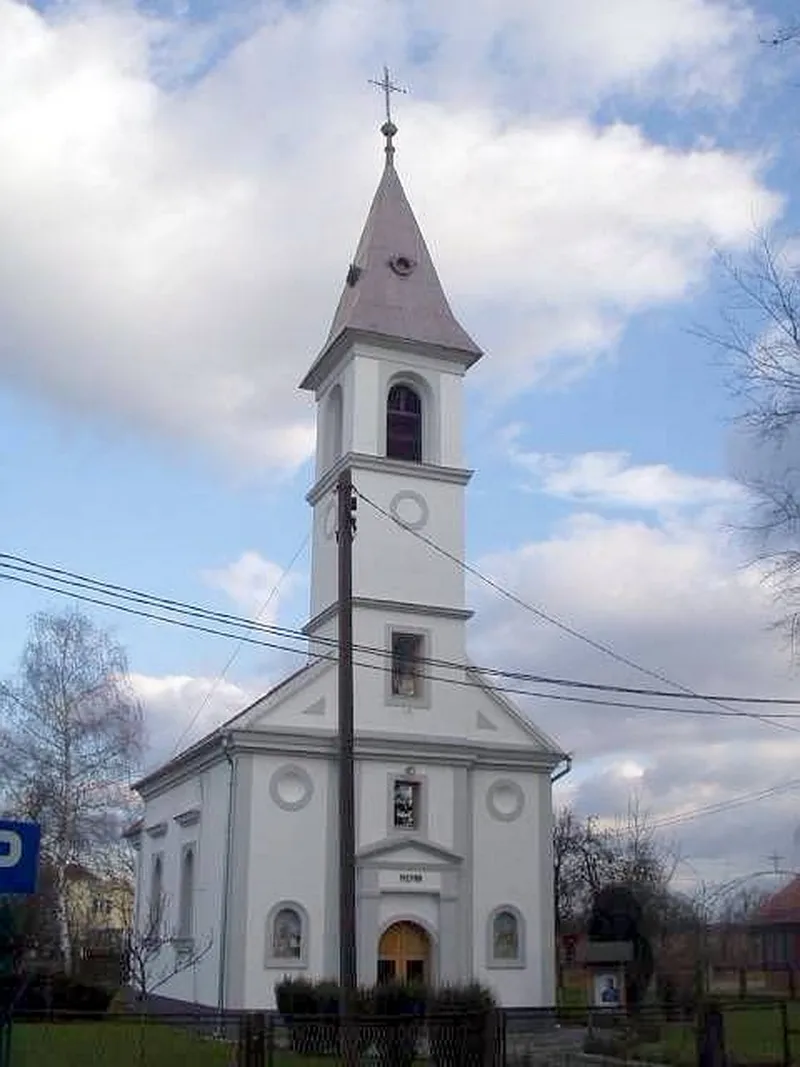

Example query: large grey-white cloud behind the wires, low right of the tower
[471,488,800,878]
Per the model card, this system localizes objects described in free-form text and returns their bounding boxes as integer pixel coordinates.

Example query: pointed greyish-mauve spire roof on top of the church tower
[302,153,481,388]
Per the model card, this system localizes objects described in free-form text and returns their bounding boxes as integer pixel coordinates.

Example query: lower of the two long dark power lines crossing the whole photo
[0,563,800,733]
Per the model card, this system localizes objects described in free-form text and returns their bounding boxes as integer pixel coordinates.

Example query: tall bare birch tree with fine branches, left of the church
[0,610,143,971]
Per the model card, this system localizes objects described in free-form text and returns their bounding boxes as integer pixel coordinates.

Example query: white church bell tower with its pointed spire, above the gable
[301,98,481,732]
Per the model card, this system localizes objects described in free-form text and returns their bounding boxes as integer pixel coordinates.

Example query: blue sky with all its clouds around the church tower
[0,0,800,877]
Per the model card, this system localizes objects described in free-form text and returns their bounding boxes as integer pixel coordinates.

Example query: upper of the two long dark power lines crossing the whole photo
[0,550,800,718]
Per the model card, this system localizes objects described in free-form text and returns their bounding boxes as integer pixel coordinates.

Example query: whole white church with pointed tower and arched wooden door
[131,112,565,1009]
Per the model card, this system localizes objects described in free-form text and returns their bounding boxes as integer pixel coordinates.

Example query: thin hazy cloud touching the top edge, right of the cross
[401,0,757,107]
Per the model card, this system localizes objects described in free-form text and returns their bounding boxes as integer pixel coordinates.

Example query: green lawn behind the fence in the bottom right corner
[636,1003,800,1067]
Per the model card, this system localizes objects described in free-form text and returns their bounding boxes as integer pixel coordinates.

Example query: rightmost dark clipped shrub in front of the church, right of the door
[428,983,498,1067]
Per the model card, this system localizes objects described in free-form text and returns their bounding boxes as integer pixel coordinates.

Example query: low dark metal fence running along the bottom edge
[0,999,800,1067]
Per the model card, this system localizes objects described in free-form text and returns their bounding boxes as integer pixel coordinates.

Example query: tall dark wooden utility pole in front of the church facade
[336,467,358,998]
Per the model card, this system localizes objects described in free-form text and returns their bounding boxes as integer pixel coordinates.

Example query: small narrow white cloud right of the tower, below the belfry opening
[509,441,743,511]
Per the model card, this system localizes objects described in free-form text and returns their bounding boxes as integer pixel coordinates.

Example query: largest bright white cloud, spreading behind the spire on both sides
[0,0,778,468]
